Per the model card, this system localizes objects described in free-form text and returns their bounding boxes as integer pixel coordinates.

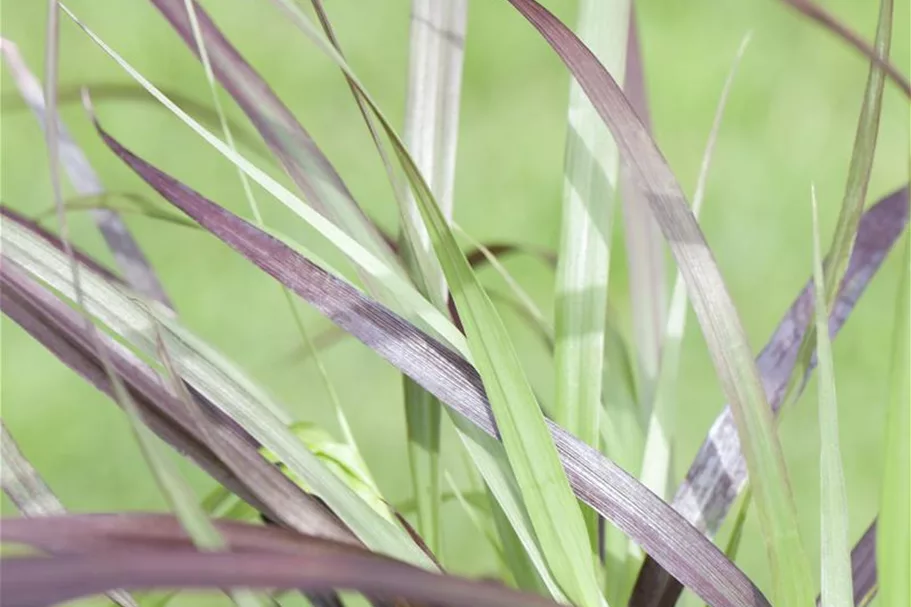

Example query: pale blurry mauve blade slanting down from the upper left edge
[0,39,173,308]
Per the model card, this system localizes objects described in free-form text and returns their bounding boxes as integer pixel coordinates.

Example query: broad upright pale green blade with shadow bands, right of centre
[553,0,630,550]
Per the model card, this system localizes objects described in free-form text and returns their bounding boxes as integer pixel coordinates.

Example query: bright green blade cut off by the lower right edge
[876,235,911,607]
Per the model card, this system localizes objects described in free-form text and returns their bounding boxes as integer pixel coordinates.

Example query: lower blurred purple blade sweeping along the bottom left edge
[0,528,555,607]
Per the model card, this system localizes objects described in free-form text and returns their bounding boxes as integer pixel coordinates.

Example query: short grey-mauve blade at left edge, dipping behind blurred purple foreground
[0,426,137,607]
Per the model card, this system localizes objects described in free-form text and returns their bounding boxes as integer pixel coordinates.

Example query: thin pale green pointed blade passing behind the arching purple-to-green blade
[640,34,750,499]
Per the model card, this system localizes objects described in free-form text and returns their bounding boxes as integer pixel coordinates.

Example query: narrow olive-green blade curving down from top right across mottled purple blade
[786,0,893,416]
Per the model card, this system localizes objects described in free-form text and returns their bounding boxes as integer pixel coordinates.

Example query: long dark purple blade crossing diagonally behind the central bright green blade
[96,123,768,607]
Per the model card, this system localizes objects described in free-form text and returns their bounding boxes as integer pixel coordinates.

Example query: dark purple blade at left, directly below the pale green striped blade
[0,256,355,543]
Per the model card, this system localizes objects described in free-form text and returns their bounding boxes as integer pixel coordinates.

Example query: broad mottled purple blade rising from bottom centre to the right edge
[630,186,908,607]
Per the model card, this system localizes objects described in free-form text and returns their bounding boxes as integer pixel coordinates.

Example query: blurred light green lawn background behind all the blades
[0,0,911,604]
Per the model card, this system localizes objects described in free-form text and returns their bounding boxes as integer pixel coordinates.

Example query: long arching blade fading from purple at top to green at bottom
[502,0,812,606]
